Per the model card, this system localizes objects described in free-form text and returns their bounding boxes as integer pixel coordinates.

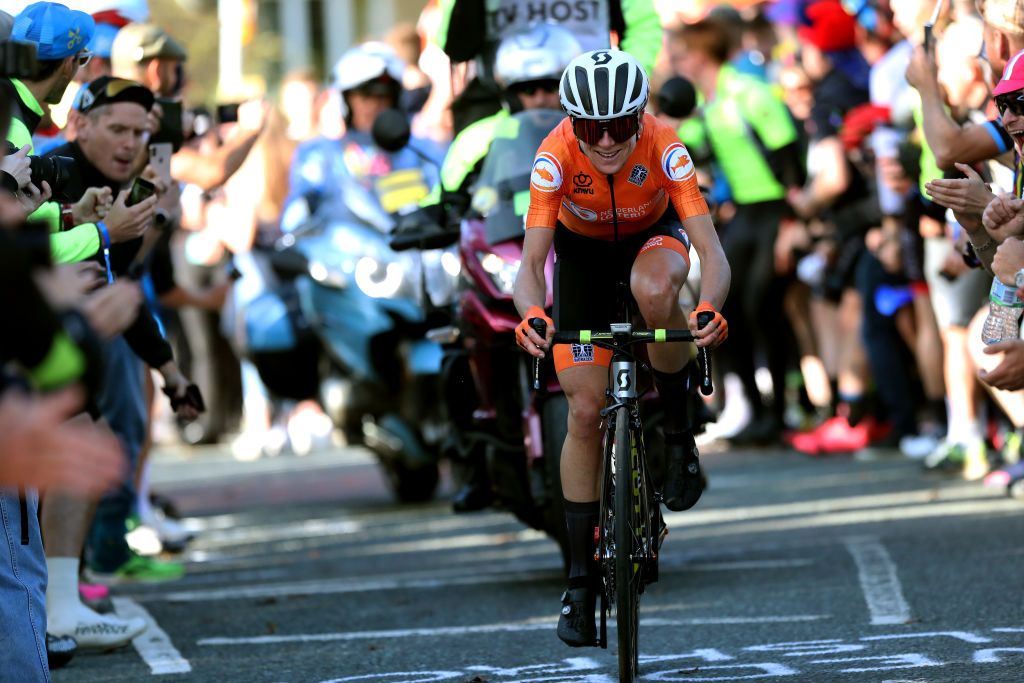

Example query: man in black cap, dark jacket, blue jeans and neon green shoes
[44,76,201,598]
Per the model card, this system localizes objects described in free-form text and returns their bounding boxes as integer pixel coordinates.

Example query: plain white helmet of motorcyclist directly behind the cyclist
[495,24,583,88]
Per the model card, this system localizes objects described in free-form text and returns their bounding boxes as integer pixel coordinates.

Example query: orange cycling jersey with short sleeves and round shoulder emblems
[526,114,708,241]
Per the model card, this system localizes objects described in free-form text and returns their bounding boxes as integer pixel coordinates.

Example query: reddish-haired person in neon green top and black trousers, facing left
[668,19,802,444]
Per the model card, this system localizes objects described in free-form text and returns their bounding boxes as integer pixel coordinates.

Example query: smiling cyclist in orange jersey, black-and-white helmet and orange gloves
[514,50,730,647]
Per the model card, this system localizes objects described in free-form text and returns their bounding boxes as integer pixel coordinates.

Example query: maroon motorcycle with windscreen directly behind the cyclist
[393,110,568,567]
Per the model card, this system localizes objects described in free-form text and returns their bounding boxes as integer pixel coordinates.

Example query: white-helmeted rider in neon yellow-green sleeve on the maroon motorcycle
[422,24,583,512]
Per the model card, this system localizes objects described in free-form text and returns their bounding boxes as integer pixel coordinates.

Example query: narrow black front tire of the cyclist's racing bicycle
[614,407,643,683]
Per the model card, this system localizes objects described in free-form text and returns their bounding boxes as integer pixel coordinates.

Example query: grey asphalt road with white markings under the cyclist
[54,440,1024,683]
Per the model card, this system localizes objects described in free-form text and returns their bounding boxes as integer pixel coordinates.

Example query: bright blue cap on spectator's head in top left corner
[10,2,95,60]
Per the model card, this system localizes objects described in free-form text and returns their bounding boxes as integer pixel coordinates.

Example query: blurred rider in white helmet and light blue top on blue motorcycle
[281,41,436,231]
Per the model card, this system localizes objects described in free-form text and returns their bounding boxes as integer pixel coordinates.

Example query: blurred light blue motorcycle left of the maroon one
[241,126,457,502]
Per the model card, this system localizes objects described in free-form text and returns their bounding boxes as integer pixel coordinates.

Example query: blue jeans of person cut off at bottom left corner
[0,489,50,683]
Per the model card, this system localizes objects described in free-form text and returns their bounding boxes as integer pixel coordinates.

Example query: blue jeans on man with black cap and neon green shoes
[88,337,148,572]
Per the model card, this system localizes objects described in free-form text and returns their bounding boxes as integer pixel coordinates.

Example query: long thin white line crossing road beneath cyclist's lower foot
[197,614,828,645]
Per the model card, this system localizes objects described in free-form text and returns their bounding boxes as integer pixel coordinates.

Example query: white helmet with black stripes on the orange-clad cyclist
[558,49,650,120]
